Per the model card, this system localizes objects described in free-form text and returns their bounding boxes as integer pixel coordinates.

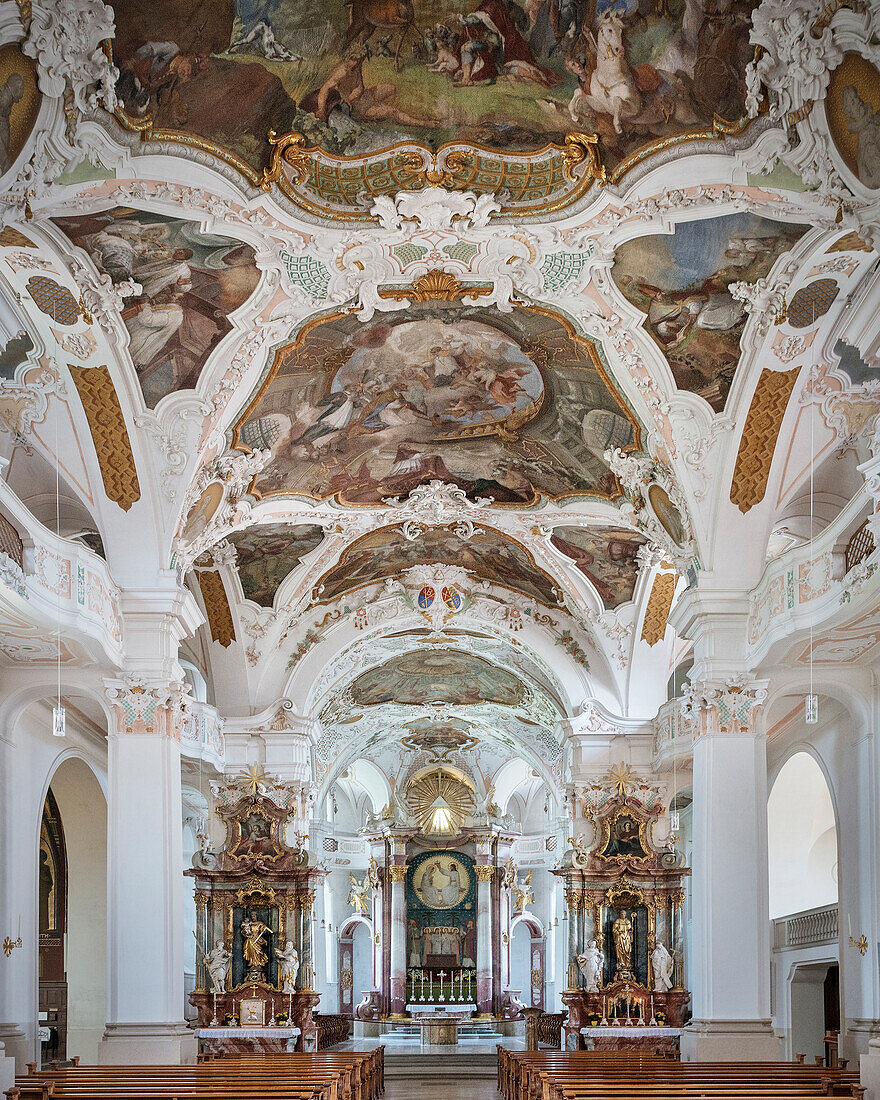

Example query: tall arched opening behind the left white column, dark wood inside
[37,758,107,1063]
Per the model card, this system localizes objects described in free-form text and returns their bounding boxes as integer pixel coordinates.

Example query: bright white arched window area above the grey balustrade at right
[767,752,837,919]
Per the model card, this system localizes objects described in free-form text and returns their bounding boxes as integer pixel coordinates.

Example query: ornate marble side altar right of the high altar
[554,765,691,1049]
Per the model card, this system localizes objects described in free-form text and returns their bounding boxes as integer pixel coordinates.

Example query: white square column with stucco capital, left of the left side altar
[99,679,197,1064]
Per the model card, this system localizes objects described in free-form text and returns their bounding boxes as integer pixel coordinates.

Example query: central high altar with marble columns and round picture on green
[339,787,545,1034]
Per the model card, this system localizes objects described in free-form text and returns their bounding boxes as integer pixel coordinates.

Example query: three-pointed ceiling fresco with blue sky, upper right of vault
[612,213,810,413]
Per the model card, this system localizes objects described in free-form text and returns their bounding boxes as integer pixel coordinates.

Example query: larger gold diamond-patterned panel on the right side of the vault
[730,366,801,514]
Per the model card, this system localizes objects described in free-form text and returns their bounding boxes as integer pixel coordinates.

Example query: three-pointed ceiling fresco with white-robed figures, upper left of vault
[55,207,260,408]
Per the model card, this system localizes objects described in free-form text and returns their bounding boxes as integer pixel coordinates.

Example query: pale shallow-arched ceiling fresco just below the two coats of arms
[349,649,526,706]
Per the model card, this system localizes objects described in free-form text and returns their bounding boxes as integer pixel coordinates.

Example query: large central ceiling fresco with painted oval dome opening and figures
[229,305,640,504]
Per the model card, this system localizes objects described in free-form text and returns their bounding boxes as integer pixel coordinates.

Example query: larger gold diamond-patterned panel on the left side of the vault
[68,366,141,512]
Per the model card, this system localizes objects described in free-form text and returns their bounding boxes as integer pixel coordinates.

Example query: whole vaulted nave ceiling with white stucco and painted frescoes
[0,0,880,792]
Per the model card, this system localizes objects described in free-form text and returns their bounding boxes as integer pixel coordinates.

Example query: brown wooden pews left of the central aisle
[6,1047,385,1100]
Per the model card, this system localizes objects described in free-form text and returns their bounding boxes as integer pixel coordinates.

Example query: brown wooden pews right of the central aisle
[498,1046,865,1100]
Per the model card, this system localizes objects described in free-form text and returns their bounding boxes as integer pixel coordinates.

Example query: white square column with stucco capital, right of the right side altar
[681,683,780,1062]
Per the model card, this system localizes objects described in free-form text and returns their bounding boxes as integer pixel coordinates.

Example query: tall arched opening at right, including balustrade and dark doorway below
[767,751,840,1062]
